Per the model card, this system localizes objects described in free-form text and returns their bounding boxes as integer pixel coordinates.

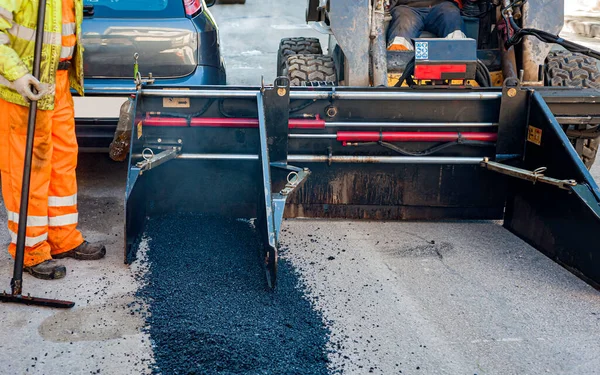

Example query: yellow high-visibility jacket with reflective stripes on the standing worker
[0,0,83,110]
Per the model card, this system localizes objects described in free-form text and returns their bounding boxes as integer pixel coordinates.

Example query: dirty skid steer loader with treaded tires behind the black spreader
[277,0,600,168]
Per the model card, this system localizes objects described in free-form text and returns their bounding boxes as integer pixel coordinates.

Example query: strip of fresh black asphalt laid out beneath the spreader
[139,215,329,374]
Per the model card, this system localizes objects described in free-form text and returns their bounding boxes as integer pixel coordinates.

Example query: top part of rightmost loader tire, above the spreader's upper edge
[546,51,600,89]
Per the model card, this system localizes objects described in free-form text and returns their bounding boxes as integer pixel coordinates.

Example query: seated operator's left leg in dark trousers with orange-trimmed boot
[388,5,427,51]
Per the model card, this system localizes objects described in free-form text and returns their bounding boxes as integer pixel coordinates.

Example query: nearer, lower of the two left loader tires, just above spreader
[284,55,337,86]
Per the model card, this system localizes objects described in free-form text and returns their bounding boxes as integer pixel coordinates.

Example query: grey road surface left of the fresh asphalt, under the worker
[0,154,152,375]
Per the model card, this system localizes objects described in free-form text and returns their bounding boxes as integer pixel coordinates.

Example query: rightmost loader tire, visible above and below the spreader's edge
[545,51,600,169]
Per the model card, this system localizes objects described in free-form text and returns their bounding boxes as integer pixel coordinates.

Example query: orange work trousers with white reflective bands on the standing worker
[0,70,83,267]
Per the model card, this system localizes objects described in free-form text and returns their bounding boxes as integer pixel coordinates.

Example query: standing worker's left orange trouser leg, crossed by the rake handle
[0,99,54,270]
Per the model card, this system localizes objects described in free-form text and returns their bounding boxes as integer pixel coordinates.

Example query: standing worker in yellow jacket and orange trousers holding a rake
[0,0,106,279]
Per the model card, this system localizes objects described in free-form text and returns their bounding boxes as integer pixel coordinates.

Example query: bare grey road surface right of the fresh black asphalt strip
[283,220,600,374]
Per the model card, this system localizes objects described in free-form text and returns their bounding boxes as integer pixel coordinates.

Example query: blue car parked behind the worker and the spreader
[75,0,226,152]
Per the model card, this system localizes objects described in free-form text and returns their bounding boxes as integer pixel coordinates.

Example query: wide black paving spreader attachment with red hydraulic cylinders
[125,1,600,288]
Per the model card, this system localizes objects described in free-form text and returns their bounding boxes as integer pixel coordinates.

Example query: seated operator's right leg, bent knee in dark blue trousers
[425,1,466,39]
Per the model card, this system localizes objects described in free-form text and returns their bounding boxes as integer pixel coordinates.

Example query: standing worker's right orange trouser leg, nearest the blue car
[48,70,83,256]
